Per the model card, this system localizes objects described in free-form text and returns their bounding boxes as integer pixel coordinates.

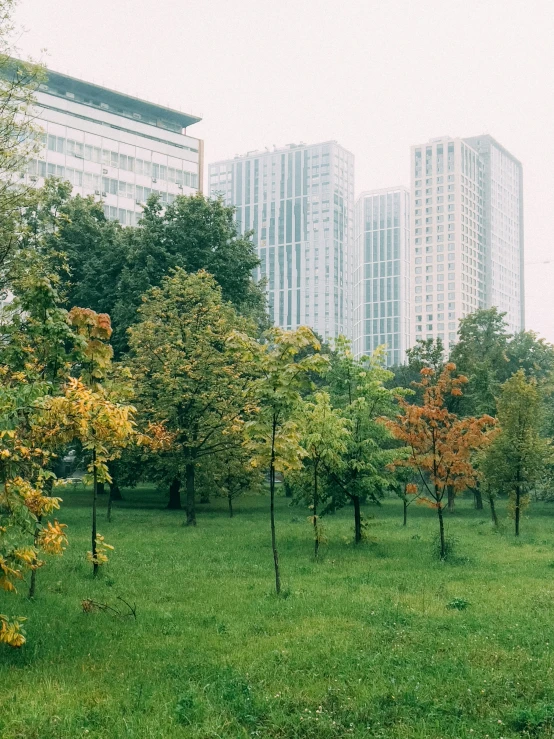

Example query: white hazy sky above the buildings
[11,0,554,342]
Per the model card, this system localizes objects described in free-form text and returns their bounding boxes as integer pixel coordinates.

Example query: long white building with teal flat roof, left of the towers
[26,71,203,225]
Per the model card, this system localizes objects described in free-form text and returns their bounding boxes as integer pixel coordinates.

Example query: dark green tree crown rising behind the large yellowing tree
[113,195,265,353]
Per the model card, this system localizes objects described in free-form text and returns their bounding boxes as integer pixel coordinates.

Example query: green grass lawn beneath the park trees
[0,489,554,739]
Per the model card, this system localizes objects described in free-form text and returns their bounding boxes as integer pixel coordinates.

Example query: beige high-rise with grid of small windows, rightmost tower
[411,137,524,356]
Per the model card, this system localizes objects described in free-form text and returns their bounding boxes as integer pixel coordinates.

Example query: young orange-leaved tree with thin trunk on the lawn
[382,362,495,559]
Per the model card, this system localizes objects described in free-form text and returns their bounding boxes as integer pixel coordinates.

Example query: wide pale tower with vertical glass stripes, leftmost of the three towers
[209,141,354,339]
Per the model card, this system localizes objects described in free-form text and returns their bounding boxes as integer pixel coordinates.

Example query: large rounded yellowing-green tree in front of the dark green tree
[130,268,251,526]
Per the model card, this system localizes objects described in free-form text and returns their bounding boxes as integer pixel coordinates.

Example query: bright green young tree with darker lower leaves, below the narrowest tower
[324,337,403,543]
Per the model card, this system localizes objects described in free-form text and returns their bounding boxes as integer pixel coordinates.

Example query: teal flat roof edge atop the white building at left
[39,69,202,133]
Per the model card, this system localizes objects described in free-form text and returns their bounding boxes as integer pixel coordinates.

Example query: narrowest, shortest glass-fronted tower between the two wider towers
[352,187,411,365]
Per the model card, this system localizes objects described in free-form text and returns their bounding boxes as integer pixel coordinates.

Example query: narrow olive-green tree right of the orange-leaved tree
[481,370,551,536]
